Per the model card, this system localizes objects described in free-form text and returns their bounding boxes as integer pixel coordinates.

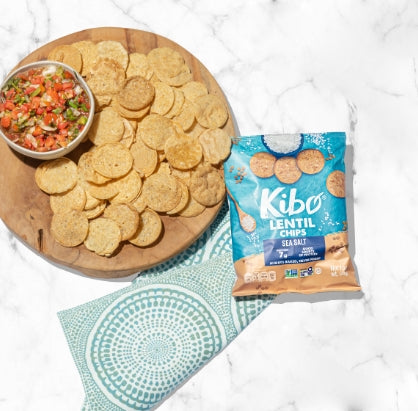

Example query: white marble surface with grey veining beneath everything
[0,0,418,411]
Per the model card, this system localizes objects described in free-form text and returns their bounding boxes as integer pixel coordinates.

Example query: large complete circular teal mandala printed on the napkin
[86,286,226,409]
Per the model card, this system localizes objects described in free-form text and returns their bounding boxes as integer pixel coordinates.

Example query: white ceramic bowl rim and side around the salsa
[0,60,94,160]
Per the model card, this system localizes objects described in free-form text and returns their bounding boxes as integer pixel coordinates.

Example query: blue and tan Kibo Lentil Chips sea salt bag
[224,132,360,296]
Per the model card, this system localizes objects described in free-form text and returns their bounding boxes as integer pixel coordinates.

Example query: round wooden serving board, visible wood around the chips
[0,27,236,278]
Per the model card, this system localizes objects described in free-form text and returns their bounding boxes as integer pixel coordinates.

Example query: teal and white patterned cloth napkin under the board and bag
[58,204,274,411]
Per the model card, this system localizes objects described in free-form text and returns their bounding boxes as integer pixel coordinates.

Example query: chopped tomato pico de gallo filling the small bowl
[0,65,90,152]
